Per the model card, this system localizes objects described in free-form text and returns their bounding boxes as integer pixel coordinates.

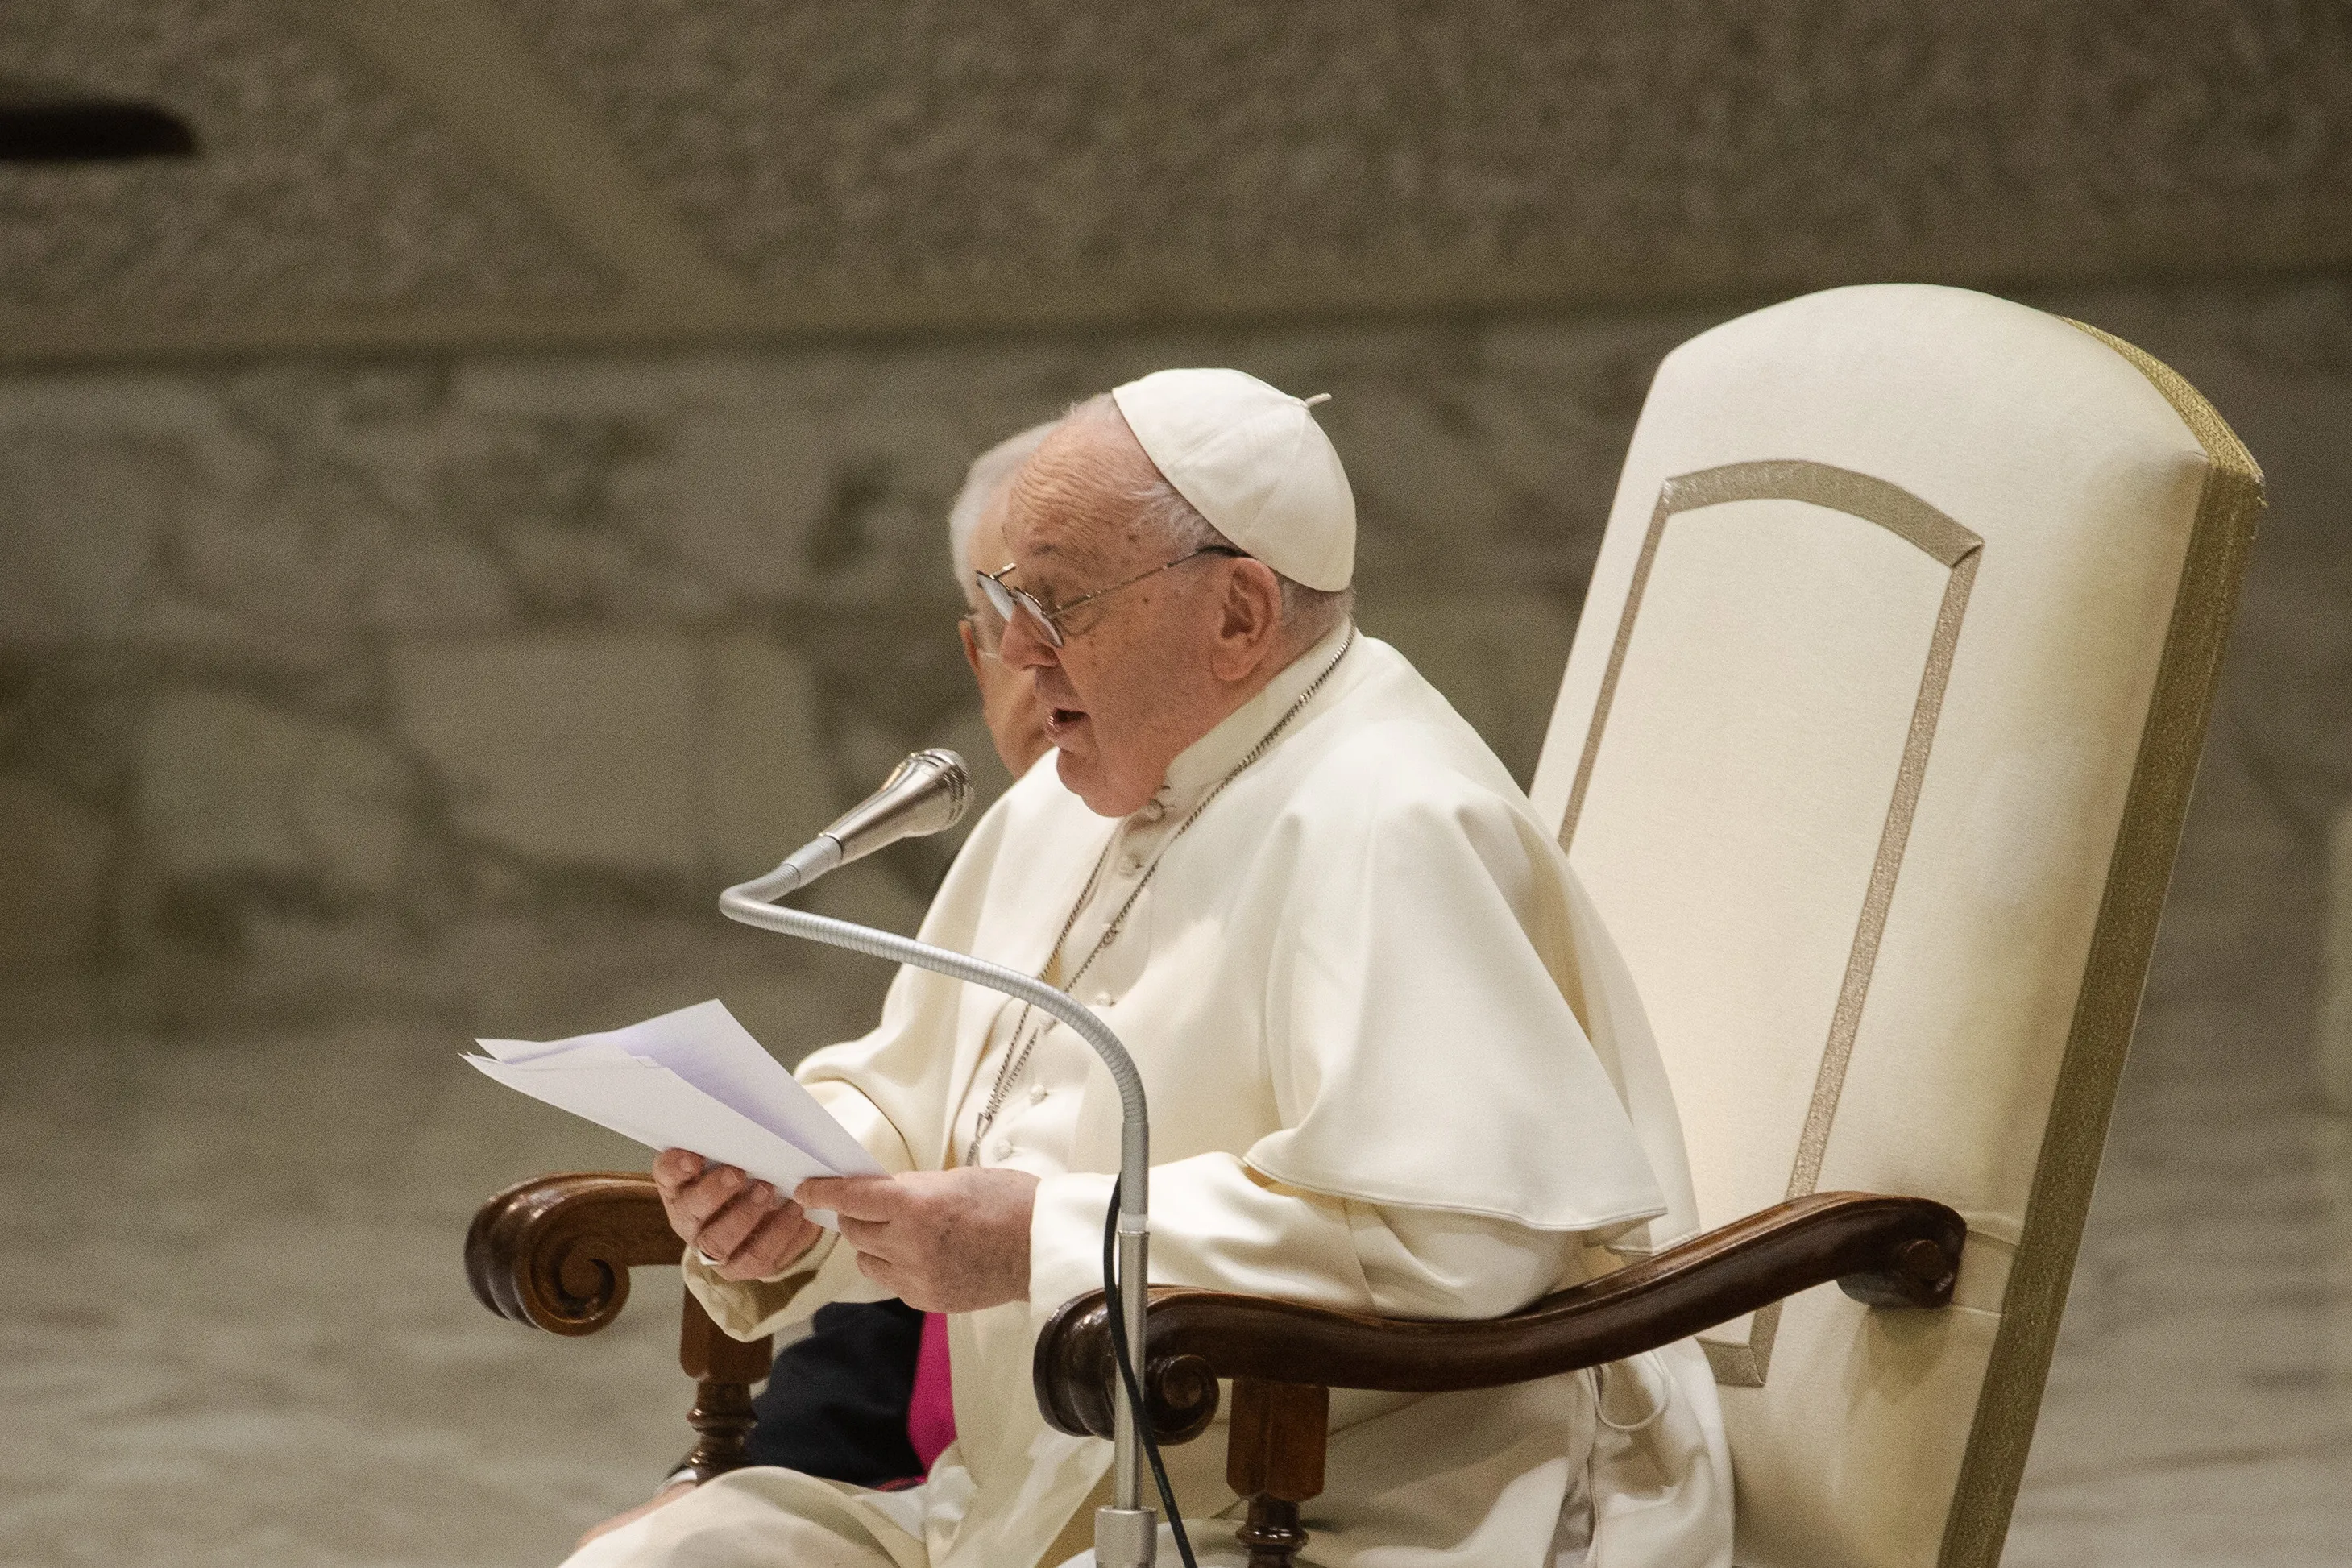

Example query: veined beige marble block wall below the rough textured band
[0,284,2352,1067]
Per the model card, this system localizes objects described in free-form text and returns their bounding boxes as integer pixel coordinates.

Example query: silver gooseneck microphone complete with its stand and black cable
[720,753,1166,1568]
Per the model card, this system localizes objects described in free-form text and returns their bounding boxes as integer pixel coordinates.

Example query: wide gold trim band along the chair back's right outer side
[1938,322,2263,1568]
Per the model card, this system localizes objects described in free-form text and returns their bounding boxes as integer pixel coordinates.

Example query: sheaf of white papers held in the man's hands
[466,1002,882,1227]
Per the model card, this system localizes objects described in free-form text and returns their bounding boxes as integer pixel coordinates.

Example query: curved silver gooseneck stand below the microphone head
[720,856,1159,1568]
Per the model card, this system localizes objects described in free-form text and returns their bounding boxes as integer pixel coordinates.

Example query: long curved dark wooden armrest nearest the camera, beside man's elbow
[1032,1192,1966,1443]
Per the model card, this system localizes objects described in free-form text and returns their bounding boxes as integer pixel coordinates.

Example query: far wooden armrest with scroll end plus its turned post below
[466,1171,771,1481]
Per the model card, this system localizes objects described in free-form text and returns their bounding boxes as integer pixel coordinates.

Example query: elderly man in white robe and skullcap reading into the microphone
[574,371,1731,1568]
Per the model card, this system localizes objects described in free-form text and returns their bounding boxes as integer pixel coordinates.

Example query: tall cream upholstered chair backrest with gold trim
[1533,284,2260,1568]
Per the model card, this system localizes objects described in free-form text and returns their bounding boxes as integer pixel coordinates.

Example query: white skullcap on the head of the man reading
[1110,369,1354,592]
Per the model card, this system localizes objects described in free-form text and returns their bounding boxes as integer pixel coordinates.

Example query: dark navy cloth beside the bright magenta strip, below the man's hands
[750,1302,922,1486]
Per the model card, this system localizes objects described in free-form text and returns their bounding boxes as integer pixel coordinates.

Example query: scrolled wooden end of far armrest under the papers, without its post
[466,1171,684,1333]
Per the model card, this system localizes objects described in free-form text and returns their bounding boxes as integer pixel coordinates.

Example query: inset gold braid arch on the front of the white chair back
[1559,461,1985,1387]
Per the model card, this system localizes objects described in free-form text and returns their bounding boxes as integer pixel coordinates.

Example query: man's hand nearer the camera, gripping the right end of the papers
[793,1171,1037,1312]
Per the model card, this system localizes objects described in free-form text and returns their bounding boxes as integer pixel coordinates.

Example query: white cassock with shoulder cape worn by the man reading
[574,630,1731,1568]
